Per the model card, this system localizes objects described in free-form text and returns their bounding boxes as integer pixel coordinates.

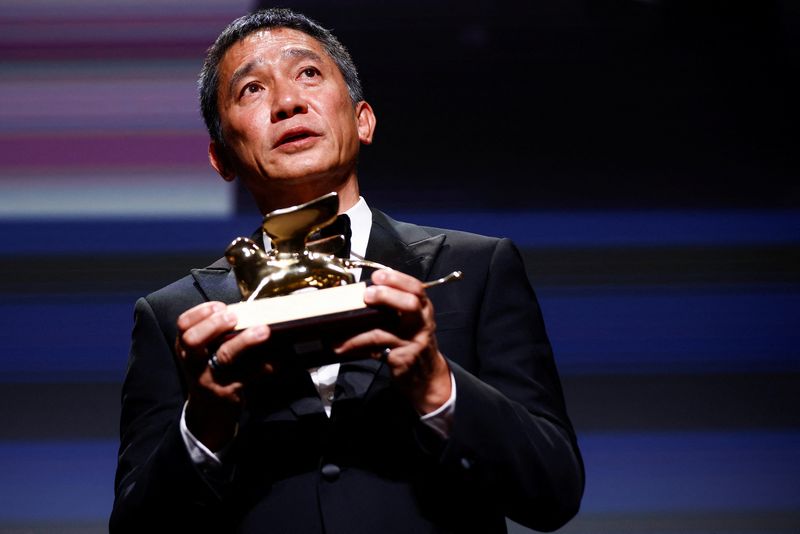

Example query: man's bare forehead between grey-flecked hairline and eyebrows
[219,28,333,76]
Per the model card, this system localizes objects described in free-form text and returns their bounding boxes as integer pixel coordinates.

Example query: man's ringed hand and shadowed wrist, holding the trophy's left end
[175,302,272,451]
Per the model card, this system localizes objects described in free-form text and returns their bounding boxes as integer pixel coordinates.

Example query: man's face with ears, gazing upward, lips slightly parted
[210,28,374,194]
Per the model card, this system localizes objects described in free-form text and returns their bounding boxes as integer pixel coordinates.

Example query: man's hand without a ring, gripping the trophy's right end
[335,269,451,415]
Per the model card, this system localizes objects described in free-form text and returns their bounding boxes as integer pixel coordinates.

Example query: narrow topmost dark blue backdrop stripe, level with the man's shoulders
[0,210,800,250]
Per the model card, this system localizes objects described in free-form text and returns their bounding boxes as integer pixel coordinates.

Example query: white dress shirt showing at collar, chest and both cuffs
[180,197,456,468]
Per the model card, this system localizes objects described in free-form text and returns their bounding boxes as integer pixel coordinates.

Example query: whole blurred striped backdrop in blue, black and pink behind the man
[0,0,800,534]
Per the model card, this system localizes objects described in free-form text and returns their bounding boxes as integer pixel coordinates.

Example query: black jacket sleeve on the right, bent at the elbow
[442,239,584,531]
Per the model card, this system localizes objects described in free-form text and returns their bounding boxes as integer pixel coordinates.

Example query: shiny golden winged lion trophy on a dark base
[216,193,461,376]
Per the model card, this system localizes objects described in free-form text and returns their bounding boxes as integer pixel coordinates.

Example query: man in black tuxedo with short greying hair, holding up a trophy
[111,9,583,534]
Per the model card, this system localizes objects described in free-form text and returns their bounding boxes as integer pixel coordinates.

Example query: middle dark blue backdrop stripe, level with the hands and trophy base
[0,288,800,382]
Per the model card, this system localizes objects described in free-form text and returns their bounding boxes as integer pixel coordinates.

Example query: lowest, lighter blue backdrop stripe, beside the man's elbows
[0,436,800,526]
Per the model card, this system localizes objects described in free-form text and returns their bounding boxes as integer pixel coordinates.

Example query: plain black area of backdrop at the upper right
[245,0,800,214]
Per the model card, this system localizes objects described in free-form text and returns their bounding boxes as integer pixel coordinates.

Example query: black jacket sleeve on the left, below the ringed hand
[109,299,228,533]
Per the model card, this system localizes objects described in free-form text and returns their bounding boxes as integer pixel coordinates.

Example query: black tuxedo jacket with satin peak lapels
[111,211,583,534]
